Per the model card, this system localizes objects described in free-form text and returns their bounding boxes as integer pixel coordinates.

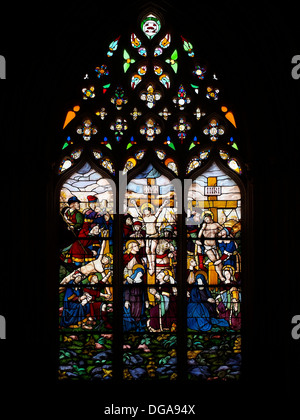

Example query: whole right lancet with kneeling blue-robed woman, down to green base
[186,163,242,380]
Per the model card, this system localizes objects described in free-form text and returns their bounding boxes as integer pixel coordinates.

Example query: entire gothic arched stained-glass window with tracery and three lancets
[56,11,247,380]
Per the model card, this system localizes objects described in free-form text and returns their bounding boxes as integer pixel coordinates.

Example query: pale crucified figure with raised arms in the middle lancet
[130,199,169,276]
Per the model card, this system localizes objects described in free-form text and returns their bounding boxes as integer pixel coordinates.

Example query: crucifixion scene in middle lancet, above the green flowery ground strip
[123,165,177,338]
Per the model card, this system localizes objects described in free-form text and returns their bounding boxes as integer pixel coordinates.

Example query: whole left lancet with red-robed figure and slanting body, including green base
[58,163,114,380]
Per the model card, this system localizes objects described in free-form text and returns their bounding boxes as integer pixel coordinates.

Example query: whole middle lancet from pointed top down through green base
[123,164,177,380]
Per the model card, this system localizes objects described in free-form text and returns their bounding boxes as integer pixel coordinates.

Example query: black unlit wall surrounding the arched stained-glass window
[0,1,300,414]
